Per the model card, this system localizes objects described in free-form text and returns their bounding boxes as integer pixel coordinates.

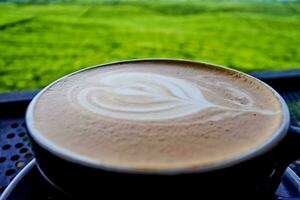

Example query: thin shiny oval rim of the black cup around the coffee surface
[25,58,290,175]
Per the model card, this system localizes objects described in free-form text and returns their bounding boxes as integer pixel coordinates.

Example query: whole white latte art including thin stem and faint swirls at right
[69,71,274,121]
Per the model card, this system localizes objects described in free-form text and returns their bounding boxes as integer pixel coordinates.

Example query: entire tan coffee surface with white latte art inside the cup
[33,60,282,170]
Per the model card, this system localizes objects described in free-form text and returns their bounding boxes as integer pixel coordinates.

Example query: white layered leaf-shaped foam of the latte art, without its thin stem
[70,72,213,121]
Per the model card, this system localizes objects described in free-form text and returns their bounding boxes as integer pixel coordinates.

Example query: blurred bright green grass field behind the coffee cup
[0,1,300,92]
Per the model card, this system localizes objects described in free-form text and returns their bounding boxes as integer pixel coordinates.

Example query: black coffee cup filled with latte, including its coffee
[26,59,300,199]
